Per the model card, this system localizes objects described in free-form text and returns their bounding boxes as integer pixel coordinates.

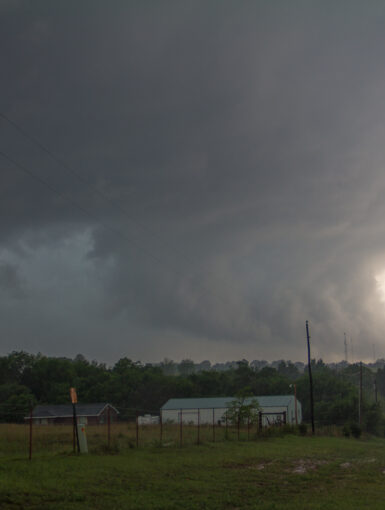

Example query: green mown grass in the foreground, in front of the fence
[0,435,385,510]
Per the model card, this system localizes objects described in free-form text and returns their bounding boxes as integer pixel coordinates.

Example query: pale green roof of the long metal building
[161,395,294,411]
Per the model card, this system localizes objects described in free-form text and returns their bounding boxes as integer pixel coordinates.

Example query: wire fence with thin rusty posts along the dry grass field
[0,406,292,458]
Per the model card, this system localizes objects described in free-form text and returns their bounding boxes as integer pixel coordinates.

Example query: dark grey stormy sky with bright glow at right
[0,0,385,363]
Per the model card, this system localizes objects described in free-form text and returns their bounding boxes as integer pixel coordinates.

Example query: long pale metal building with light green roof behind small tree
[160,395,302,427]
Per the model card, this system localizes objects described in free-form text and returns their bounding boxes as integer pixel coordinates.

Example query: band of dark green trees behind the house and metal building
[0,352,385,435]
